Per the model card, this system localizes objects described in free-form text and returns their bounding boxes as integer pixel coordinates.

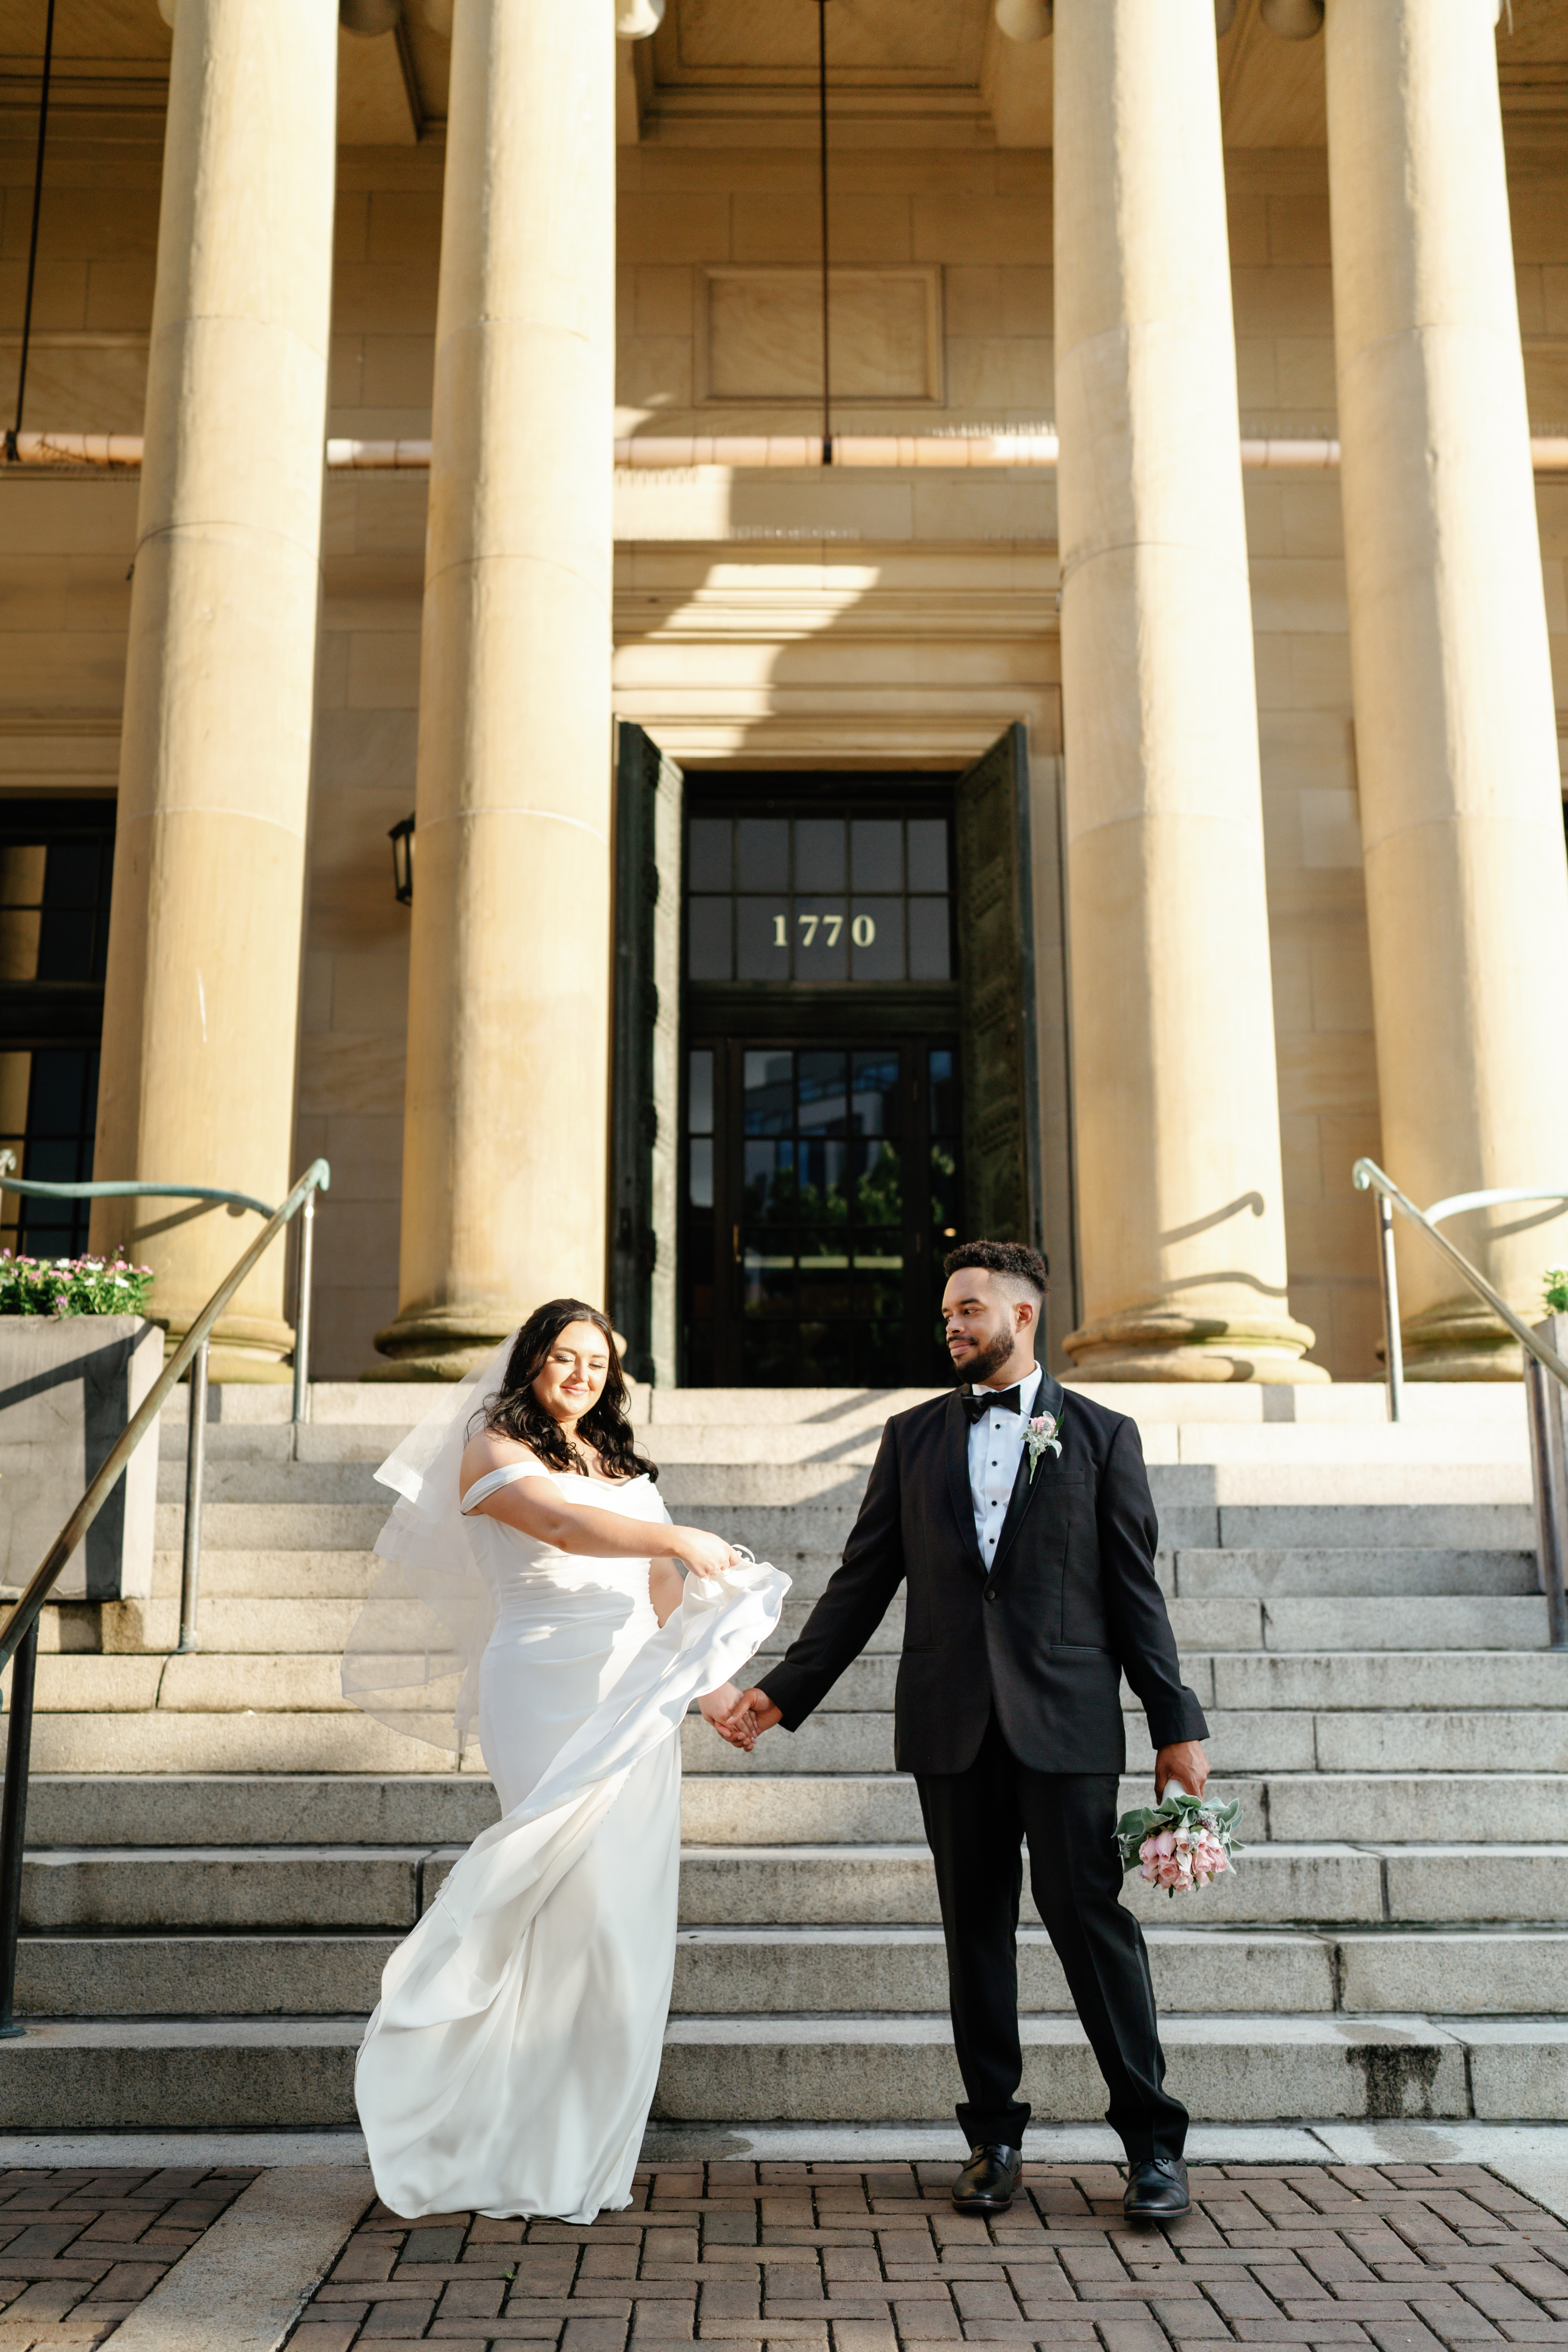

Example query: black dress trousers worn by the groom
[915,1715,1187,2164]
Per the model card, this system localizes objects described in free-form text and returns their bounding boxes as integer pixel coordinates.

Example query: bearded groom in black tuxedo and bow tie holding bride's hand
[729,1242,1208,2220]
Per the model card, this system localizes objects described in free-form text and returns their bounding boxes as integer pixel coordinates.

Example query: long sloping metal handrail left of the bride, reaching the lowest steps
[0,1160,332,2039]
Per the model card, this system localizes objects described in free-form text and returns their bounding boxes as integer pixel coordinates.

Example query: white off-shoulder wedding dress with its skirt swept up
[355,1463,788,2223]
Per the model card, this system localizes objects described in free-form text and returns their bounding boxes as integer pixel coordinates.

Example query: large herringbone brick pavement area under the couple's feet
[278,2164,1568,2352]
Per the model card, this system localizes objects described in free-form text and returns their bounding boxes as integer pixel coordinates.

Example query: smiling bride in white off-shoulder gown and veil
[343,1298,788,2223]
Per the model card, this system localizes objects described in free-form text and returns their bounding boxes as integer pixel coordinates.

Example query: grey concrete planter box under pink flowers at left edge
[0,1315,165,1602]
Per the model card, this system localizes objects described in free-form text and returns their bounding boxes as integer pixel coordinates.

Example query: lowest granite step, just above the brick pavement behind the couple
[0,2013,1568,2131]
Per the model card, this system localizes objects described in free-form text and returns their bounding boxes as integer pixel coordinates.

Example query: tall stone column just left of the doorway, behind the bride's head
[376,0,616,1378]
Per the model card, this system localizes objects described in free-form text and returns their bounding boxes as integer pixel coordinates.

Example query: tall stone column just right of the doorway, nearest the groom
[1056,0,1323,1381]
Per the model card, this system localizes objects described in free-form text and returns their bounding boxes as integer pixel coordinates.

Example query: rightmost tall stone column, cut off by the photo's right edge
[1326,0,1568,1381]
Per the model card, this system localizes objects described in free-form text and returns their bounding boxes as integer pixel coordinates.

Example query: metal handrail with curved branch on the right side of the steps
[1349,1160,1568,1649]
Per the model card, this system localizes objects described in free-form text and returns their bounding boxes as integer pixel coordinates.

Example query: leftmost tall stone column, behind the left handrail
[92,0,339,1381]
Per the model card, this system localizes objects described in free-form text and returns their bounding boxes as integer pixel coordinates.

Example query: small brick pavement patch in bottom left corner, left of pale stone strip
[0,2164,256,2352]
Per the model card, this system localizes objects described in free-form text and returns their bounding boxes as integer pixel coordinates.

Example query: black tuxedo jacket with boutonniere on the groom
[757,1374,1208,1773]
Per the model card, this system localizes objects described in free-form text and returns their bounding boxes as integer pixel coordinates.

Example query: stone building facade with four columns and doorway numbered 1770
[0,0,1568,1385]
